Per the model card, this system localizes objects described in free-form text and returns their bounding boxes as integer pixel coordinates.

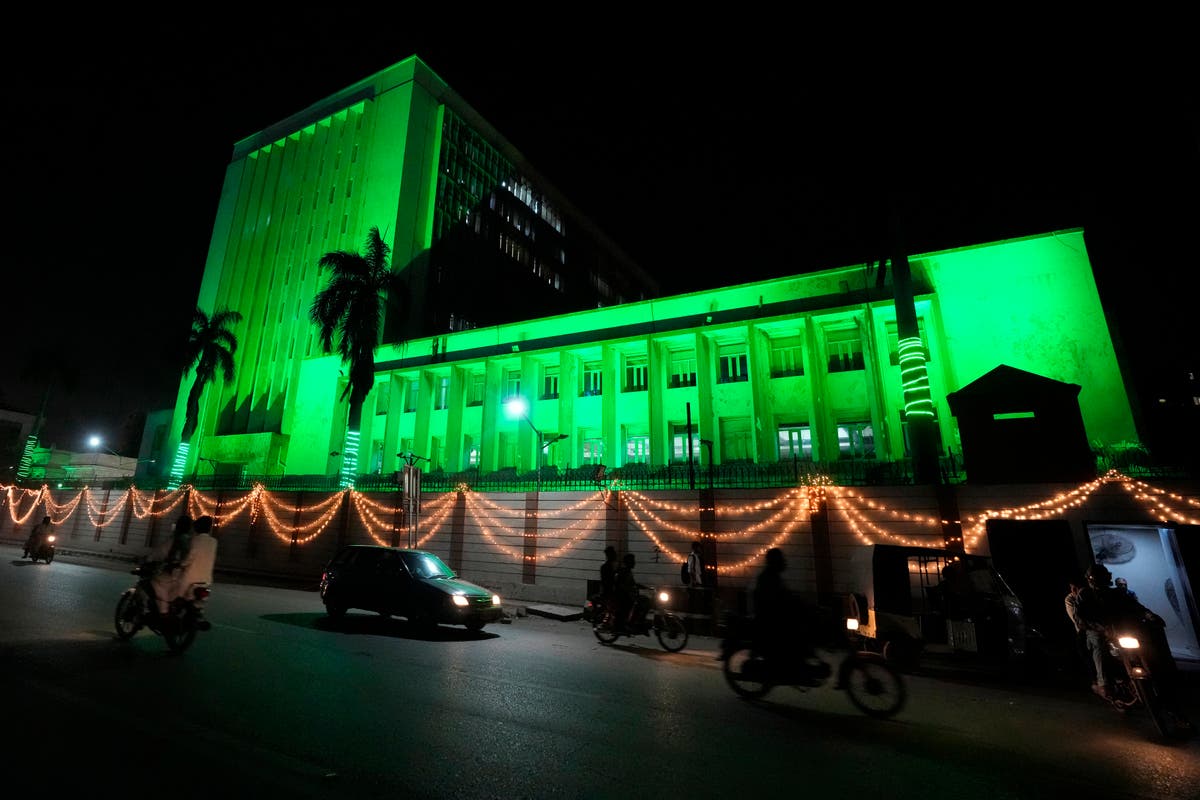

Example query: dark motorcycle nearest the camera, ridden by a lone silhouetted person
[721,615,907,718]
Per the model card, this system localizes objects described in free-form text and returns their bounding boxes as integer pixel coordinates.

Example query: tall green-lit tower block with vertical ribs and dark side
[173,58,658,482]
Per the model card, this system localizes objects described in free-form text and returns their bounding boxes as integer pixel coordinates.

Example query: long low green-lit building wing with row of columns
[280,225,1135,474]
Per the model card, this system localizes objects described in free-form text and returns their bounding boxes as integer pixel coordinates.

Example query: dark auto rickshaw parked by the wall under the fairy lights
[847,545,1027,669]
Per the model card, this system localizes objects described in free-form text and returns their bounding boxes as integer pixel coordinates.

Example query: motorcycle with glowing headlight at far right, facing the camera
[1104,627,1193,739]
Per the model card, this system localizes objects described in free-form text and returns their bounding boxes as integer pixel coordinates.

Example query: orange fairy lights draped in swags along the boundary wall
[0,470,1200,573]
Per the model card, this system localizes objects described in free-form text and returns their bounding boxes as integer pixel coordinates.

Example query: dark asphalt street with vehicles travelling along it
[0,545,1200,800]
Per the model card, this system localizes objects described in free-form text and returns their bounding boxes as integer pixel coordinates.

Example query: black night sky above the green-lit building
[0,15,1200,449]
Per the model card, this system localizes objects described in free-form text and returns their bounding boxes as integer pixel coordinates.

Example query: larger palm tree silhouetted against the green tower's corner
[308,225,404,434]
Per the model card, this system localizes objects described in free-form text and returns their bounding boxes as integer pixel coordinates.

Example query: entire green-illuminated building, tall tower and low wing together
[172,59,1136,475]
